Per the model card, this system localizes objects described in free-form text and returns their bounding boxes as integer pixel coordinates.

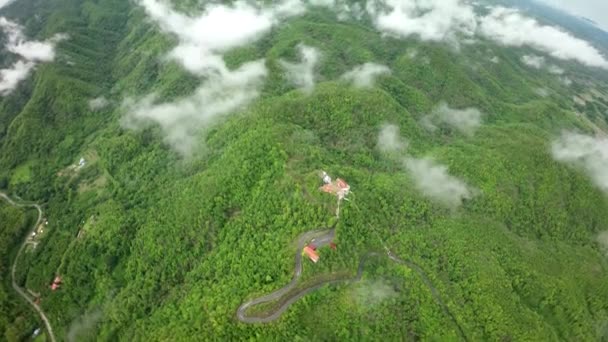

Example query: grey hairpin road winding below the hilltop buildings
[236,228,468,341]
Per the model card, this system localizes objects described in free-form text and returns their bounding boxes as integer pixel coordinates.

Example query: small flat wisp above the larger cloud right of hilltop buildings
[422,103,483,135]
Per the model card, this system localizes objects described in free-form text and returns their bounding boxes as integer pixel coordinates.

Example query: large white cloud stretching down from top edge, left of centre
[123,0,305,156]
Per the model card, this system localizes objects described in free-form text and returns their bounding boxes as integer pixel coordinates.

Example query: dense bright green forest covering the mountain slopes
[0,0,608,340]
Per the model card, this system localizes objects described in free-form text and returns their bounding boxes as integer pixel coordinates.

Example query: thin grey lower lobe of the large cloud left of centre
[123,61,267,157]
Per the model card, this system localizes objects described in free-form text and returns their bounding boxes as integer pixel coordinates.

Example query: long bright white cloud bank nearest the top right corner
[479,7,608,69]
